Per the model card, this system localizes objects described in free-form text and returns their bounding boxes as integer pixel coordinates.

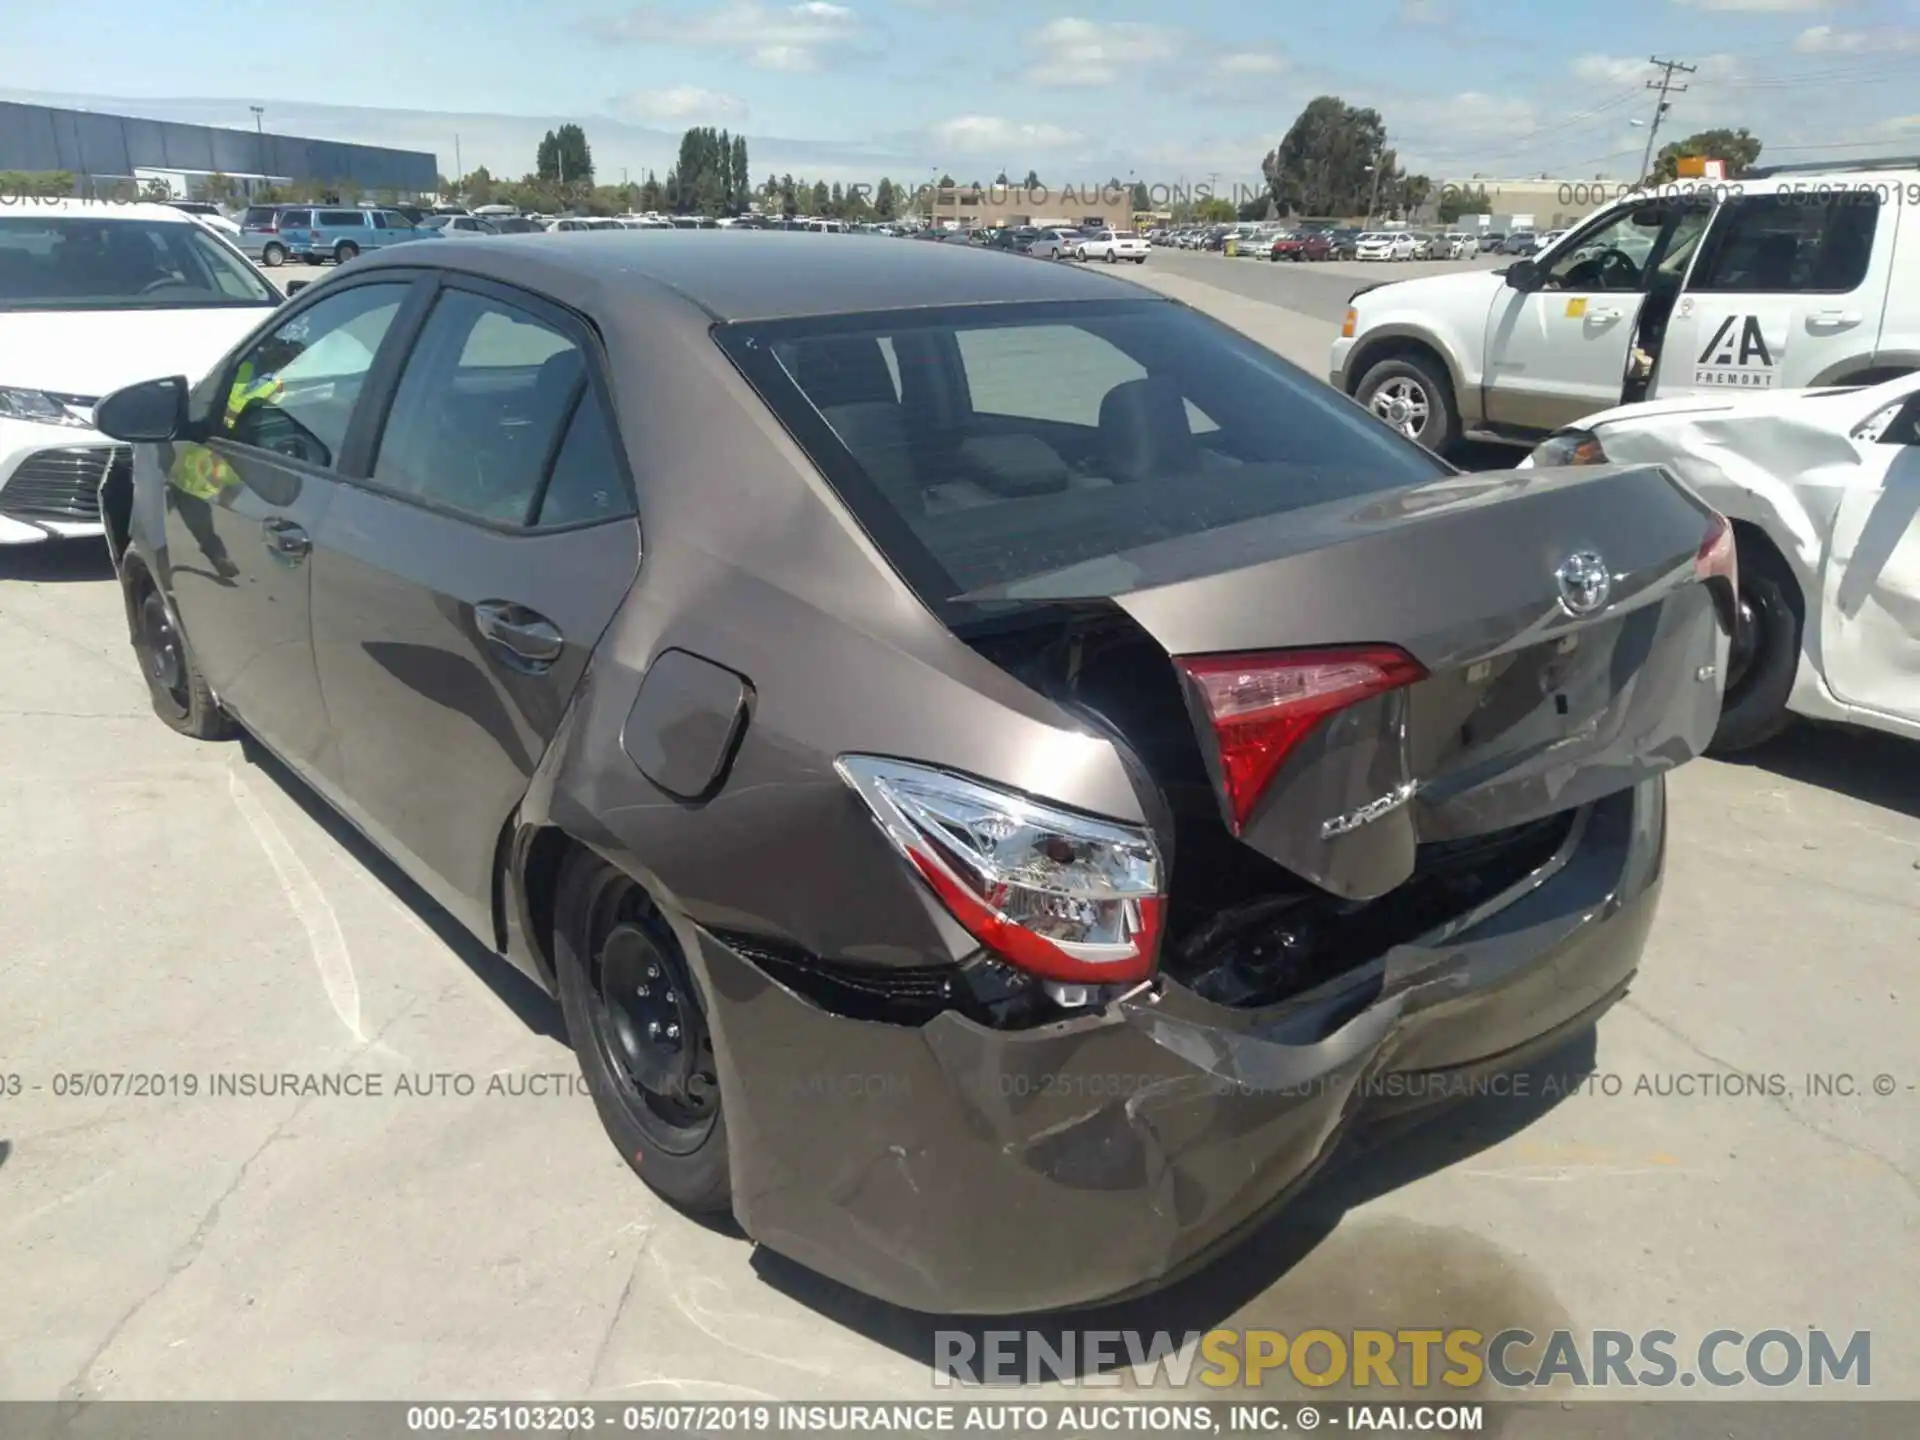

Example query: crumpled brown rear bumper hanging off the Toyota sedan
[695,780,1667,1313]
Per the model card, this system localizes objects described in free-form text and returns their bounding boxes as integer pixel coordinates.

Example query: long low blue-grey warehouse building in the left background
[0,102,440,198]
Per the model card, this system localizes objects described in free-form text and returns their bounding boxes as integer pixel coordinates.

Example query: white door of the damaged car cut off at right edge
[1820,396,1920,722]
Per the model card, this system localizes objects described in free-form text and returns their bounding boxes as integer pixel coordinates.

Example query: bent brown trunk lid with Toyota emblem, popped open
[1114,467,1726,900]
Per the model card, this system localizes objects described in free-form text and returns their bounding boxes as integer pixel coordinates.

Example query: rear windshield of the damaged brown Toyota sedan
[716,300,1450,614]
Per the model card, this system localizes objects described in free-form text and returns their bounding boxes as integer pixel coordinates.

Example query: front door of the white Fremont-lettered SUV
[1486,204,1707,432]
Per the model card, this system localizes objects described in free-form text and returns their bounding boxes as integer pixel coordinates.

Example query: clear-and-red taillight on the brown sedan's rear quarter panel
[835,755,1165,985]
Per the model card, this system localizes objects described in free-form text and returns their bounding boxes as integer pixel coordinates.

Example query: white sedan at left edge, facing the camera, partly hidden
[0,200,280,545]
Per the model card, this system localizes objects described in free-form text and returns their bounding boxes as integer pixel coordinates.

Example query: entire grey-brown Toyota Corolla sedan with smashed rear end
[100,234,1732,1313]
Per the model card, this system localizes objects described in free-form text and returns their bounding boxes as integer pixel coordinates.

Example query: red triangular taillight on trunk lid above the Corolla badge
[1175,645,1427,833]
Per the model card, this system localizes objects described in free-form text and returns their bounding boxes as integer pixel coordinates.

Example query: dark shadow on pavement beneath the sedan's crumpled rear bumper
[753,1025,1597,1377]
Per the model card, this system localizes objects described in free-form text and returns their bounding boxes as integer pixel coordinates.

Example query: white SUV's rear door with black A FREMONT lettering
[1651,190,1899,397]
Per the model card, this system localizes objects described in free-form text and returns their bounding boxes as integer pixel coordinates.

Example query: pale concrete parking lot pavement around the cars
[0,252,1920,1413]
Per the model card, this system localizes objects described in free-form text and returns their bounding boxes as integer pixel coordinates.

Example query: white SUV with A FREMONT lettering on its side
[1331,171,1920,462]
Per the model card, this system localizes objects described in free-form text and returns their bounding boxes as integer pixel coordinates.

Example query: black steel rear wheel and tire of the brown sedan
[553,851,732,1213]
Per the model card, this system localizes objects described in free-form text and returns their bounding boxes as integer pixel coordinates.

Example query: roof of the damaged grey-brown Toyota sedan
[341,228,1154,321]
